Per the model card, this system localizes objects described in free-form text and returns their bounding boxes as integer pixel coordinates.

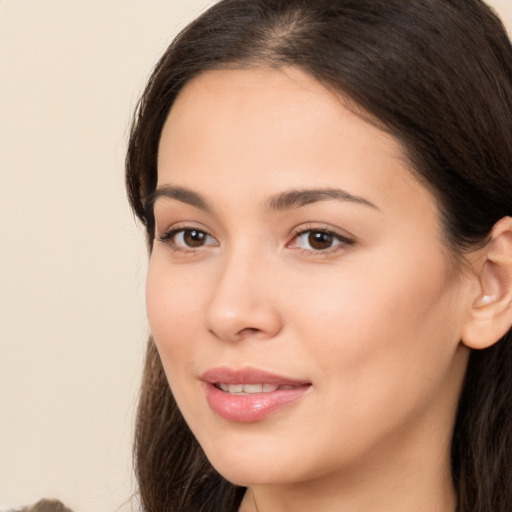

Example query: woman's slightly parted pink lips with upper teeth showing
[201,367,311,423]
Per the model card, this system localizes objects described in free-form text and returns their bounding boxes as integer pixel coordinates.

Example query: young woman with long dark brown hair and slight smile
[127,0,512,512]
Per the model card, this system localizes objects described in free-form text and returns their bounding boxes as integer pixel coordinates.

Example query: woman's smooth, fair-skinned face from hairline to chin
[147,69,469,485]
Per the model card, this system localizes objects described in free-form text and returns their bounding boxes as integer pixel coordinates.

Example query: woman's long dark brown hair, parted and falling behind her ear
[126,0,512,512]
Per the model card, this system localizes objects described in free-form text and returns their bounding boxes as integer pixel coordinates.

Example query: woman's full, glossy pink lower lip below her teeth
[205,383,311,423]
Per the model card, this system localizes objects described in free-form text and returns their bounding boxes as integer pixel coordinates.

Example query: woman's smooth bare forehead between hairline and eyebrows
[158,68,433,222]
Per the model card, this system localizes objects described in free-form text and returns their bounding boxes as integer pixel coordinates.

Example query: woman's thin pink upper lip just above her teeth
[201,366,311,386]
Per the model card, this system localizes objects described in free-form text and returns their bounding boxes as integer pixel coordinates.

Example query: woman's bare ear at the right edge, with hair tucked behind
[462,217,512,349]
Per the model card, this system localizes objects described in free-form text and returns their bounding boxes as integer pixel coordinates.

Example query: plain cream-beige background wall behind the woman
[0,0,512,512]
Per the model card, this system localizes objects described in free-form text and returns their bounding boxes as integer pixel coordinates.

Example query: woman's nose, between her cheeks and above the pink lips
[206,250,283,342]
